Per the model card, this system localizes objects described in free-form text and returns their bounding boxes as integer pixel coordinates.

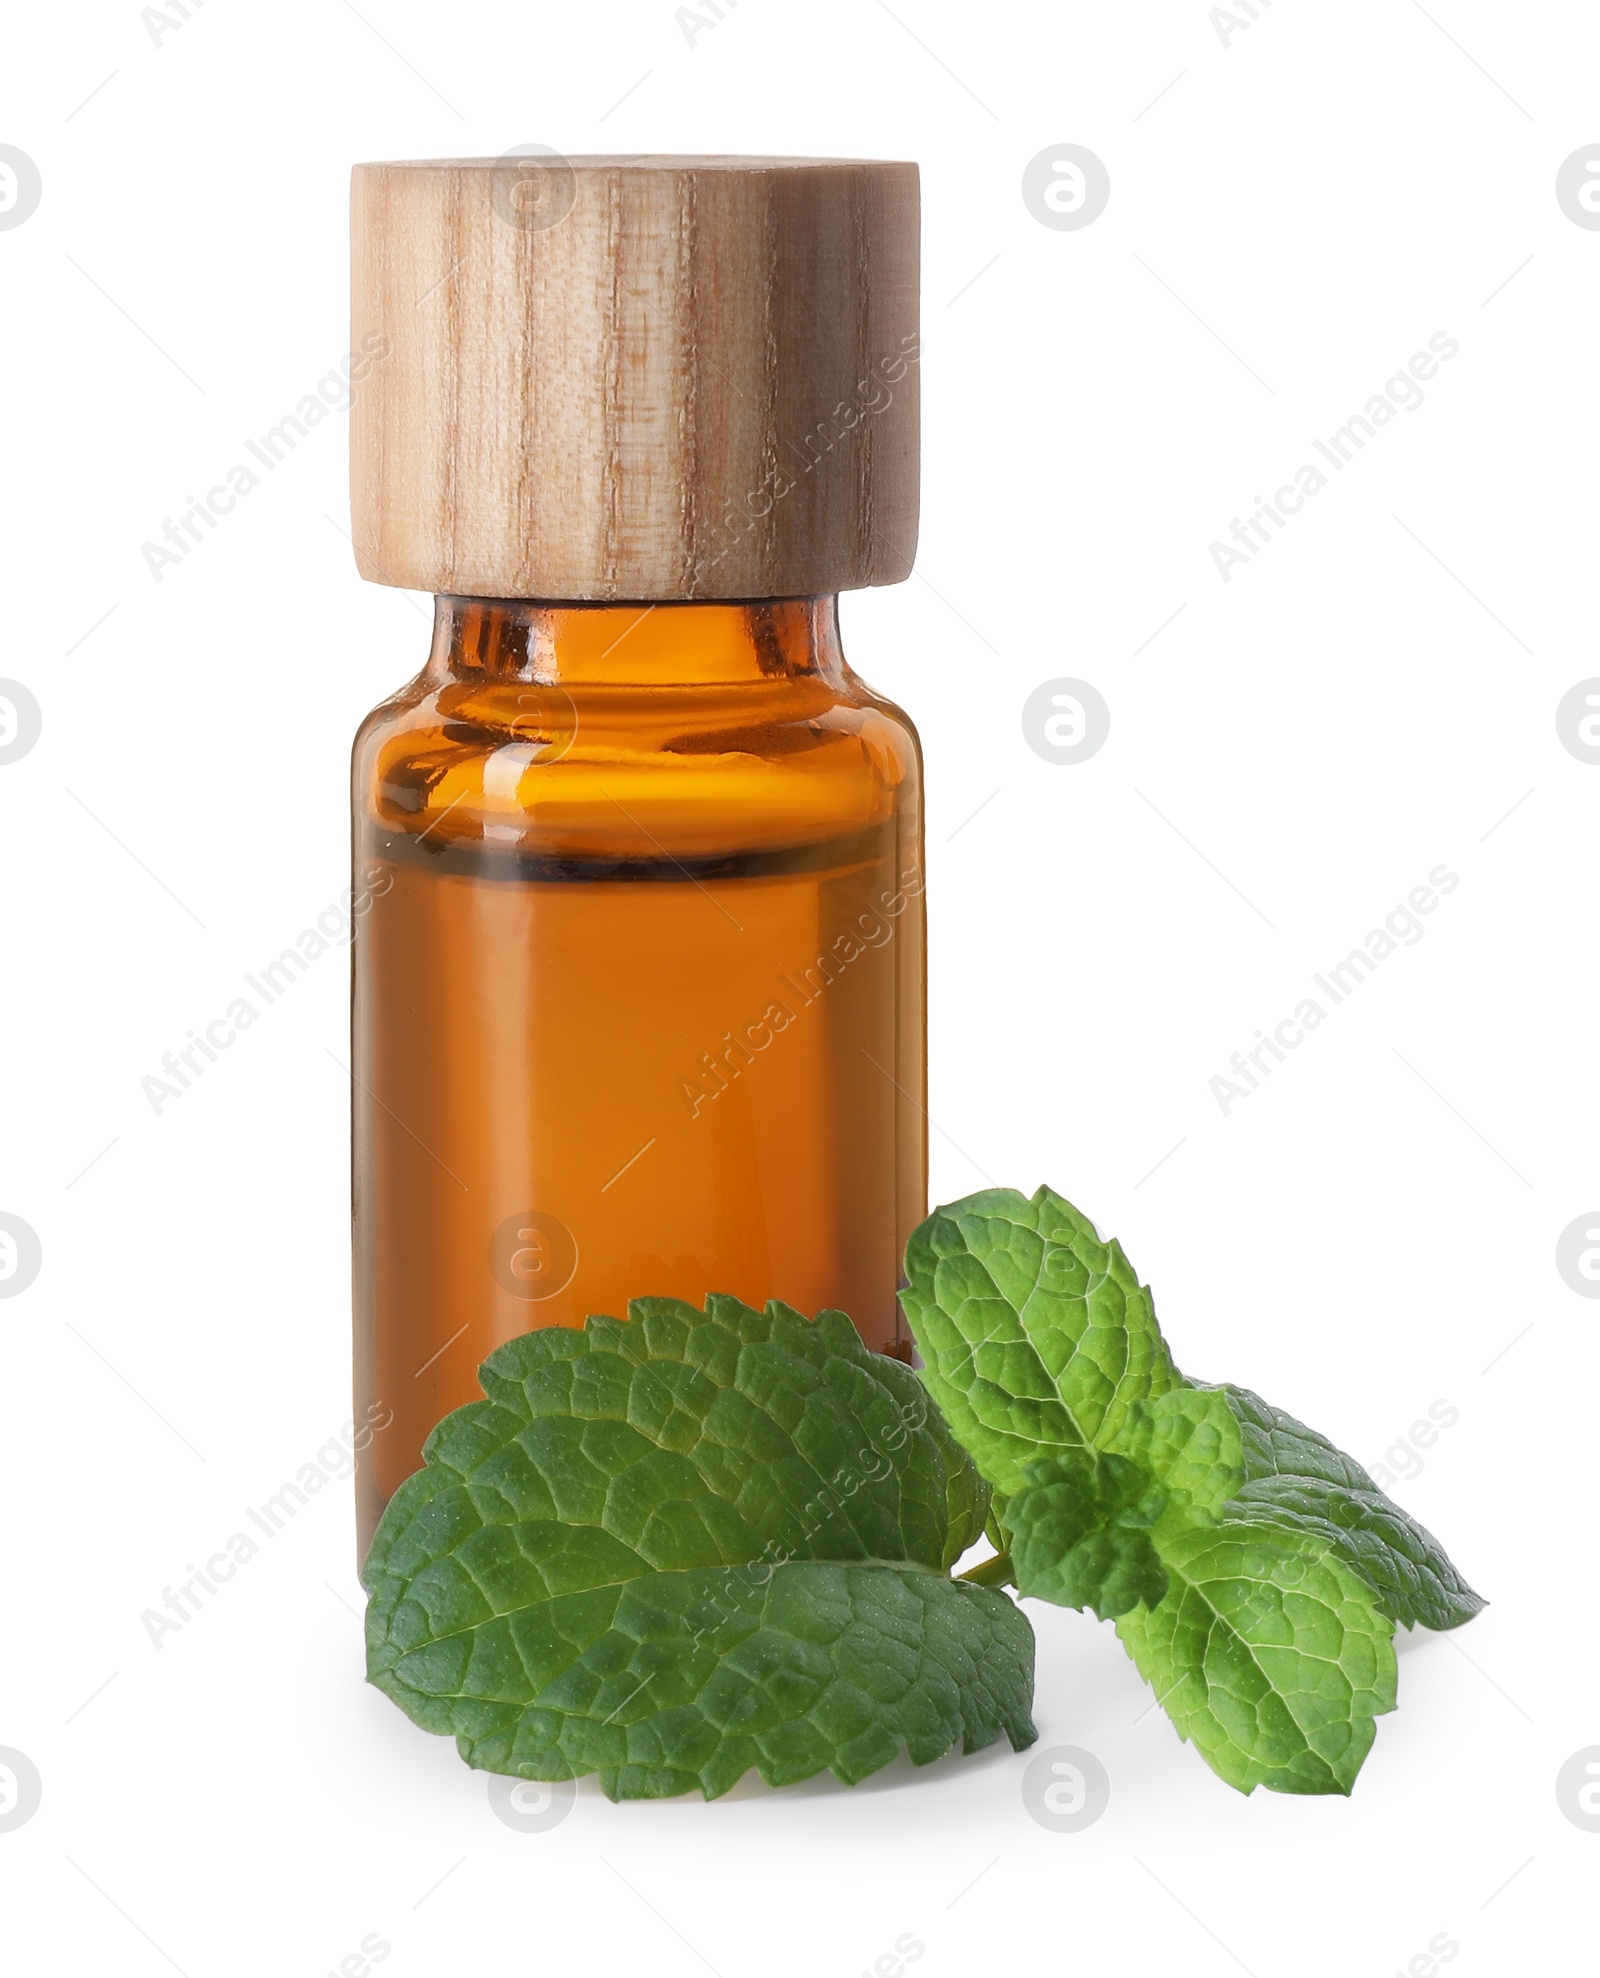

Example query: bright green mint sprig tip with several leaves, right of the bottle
[902,1189,1483,1792]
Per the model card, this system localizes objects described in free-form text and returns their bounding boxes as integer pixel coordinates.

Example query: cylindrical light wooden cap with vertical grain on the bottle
[350,152,918,599]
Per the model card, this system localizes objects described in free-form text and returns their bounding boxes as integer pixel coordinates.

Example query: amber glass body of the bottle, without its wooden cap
[354,597,926,1542]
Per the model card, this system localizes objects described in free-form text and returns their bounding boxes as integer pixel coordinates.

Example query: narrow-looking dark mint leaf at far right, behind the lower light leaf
[1220,1387,1483,1628]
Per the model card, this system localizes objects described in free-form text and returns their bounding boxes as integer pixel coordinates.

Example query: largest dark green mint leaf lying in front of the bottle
[364,1298,1034,1798]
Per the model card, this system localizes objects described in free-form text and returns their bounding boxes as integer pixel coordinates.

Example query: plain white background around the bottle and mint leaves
[0,0,1600,1978]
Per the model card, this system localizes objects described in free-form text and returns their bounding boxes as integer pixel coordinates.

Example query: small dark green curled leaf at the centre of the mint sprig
[1007,1450,1167,1620]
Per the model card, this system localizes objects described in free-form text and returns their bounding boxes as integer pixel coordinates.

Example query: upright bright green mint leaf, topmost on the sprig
[900,1189,1179,1495]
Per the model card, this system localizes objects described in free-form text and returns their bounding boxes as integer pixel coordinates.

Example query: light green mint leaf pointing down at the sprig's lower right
[1117,1519,1396,1792]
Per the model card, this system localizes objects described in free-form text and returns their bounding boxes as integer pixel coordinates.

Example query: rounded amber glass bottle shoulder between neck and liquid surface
[354,669,922,858]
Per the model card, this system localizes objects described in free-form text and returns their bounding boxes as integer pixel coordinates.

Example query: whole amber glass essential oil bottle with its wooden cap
[352,156,928,1549]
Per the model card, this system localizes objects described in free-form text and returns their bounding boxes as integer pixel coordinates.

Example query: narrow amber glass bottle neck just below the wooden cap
[427,597,844,686]
